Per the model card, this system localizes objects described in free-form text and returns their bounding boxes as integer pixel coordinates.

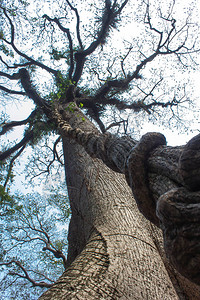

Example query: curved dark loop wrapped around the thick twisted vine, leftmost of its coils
[125,132,166,226]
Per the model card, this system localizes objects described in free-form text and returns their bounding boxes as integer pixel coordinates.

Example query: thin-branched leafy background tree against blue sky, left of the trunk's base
[0,189,69,299]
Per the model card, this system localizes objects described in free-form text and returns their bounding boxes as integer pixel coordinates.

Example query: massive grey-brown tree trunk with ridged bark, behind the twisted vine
[40,114,200,300]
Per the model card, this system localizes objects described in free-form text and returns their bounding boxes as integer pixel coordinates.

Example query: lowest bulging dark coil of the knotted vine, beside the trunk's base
[157,188,200,284]
